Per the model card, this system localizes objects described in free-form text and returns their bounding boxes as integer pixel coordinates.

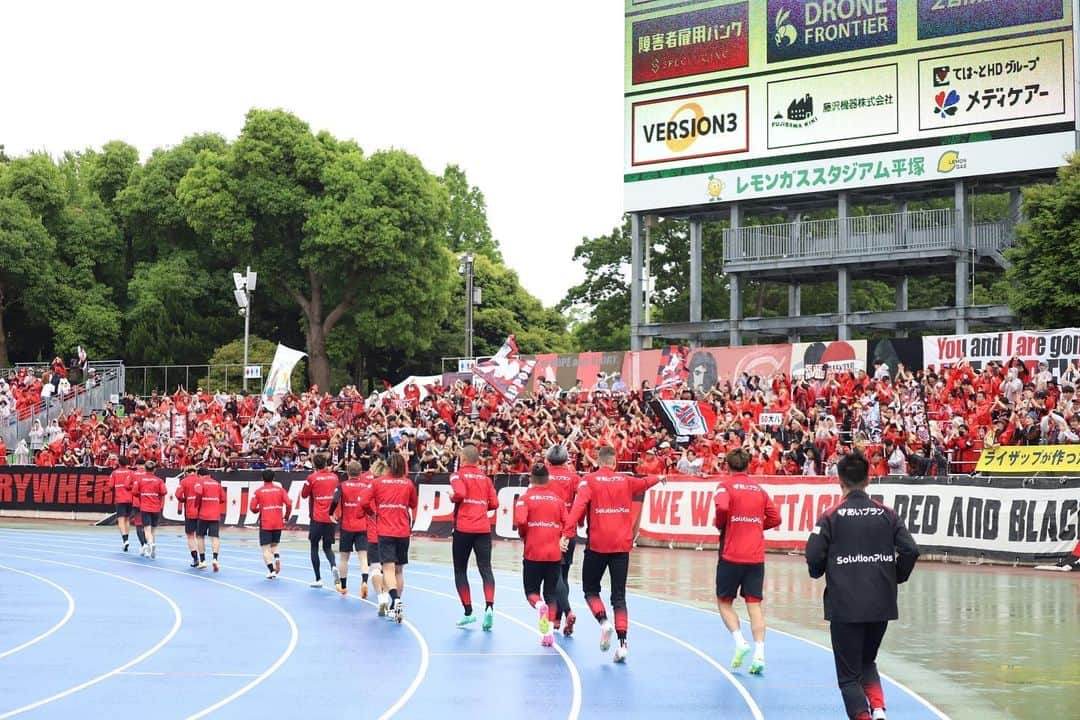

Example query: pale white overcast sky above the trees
[0,0,623,305]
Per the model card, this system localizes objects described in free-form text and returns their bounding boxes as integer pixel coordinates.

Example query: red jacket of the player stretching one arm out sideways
[563,467,660,553]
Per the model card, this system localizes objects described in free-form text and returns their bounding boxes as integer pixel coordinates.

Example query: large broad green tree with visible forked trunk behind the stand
[177,110,448,388]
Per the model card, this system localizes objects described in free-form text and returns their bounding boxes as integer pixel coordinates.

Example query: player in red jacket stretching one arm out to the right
[562,445,662,663]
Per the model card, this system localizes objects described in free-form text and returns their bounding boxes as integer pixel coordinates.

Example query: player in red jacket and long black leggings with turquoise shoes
[450,445,499,630]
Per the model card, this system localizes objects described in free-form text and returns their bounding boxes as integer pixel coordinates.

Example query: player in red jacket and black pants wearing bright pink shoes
[514,464,566,647]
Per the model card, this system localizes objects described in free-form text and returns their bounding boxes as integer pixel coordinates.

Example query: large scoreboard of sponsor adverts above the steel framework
[623,0,1077,212]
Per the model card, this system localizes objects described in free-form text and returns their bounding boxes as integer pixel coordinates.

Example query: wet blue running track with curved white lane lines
[0,528,945,720]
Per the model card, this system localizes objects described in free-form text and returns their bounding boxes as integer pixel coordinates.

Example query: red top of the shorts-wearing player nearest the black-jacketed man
[714,473,780,565]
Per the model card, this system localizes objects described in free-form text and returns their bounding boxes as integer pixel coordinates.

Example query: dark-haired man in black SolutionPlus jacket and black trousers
[806,453,919,720]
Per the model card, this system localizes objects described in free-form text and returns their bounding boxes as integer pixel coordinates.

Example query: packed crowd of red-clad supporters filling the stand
[0,358,1080,475]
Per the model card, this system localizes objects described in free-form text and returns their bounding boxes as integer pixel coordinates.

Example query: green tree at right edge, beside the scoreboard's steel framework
[1005,154,1080,327]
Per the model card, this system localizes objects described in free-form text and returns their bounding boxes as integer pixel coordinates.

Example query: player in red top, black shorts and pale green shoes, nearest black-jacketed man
[714,448,780,675]
